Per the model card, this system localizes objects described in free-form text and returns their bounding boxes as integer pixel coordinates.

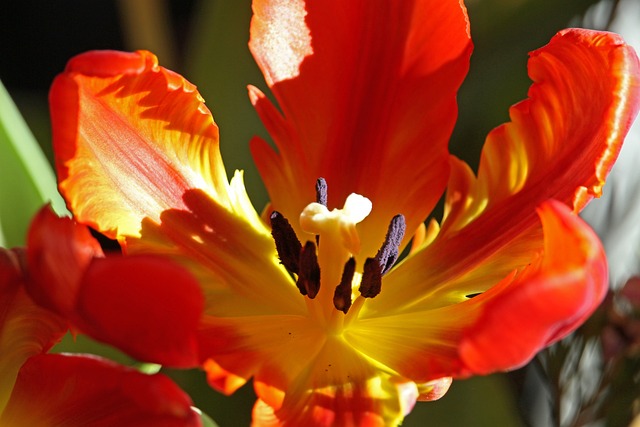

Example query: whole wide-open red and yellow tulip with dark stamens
[50,0,640,426]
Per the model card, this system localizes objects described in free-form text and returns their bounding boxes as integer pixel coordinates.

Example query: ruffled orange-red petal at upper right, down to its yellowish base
[374,30,640,306]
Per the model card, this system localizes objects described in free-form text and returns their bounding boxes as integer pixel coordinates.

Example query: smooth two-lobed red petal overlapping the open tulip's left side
[27,208,204,366]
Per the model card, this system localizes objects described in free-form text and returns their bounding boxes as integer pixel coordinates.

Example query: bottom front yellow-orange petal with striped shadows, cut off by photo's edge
[253,338,419,427]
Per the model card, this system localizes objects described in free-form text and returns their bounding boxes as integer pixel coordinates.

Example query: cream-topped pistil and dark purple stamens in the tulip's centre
[271,178,406,317]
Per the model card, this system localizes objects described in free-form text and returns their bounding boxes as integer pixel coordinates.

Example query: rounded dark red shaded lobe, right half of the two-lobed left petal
[77,255,204,367]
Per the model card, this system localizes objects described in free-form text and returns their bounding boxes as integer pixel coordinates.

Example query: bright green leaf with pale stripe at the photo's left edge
[0,82,66,247]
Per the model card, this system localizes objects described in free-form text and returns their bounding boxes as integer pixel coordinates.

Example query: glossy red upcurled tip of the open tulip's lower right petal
[460,202,608,374]
